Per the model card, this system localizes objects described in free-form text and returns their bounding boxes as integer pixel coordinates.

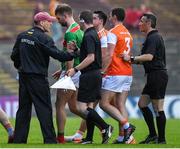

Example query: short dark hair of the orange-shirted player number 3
[111,8,125,22]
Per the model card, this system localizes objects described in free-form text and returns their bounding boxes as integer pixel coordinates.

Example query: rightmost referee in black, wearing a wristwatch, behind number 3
[124,14,168,144]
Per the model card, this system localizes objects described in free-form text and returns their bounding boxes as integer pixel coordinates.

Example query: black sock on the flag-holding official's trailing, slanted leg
[87,107,109,130]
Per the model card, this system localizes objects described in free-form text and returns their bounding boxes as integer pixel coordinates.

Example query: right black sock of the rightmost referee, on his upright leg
[156,111,166,142]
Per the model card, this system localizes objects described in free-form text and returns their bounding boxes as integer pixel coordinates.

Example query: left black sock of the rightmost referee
[140,107,157,137]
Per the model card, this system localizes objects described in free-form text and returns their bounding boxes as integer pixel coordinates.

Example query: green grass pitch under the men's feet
[0,118,180,148]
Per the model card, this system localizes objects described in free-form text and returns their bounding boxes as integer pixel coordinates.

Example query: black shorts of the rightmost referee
[142,70,168,99]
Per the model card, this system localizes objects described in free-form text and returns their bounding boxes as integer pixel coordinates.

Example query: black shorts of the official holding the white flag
[78,70,102,103]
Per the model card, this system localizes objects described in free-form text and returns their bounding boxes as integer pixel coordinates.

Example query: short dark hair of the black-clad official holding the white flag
[79,10,93,24]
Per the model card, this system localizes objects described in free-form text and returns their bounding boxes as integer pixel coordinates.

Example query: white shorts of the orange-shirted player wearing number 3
[102,76,132,93]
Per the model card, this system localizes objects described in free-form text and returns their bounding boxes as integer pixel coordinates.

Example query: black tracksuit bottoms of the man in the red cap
[14,73,56,143]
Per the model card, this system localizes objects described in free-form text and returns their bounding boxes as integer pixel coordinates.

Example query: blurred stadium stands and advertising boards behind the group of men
[0,0,180,118]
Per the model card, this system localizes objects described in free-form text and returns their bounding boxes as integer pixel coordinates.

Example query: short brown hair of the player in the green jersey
[55,3,73,15]
